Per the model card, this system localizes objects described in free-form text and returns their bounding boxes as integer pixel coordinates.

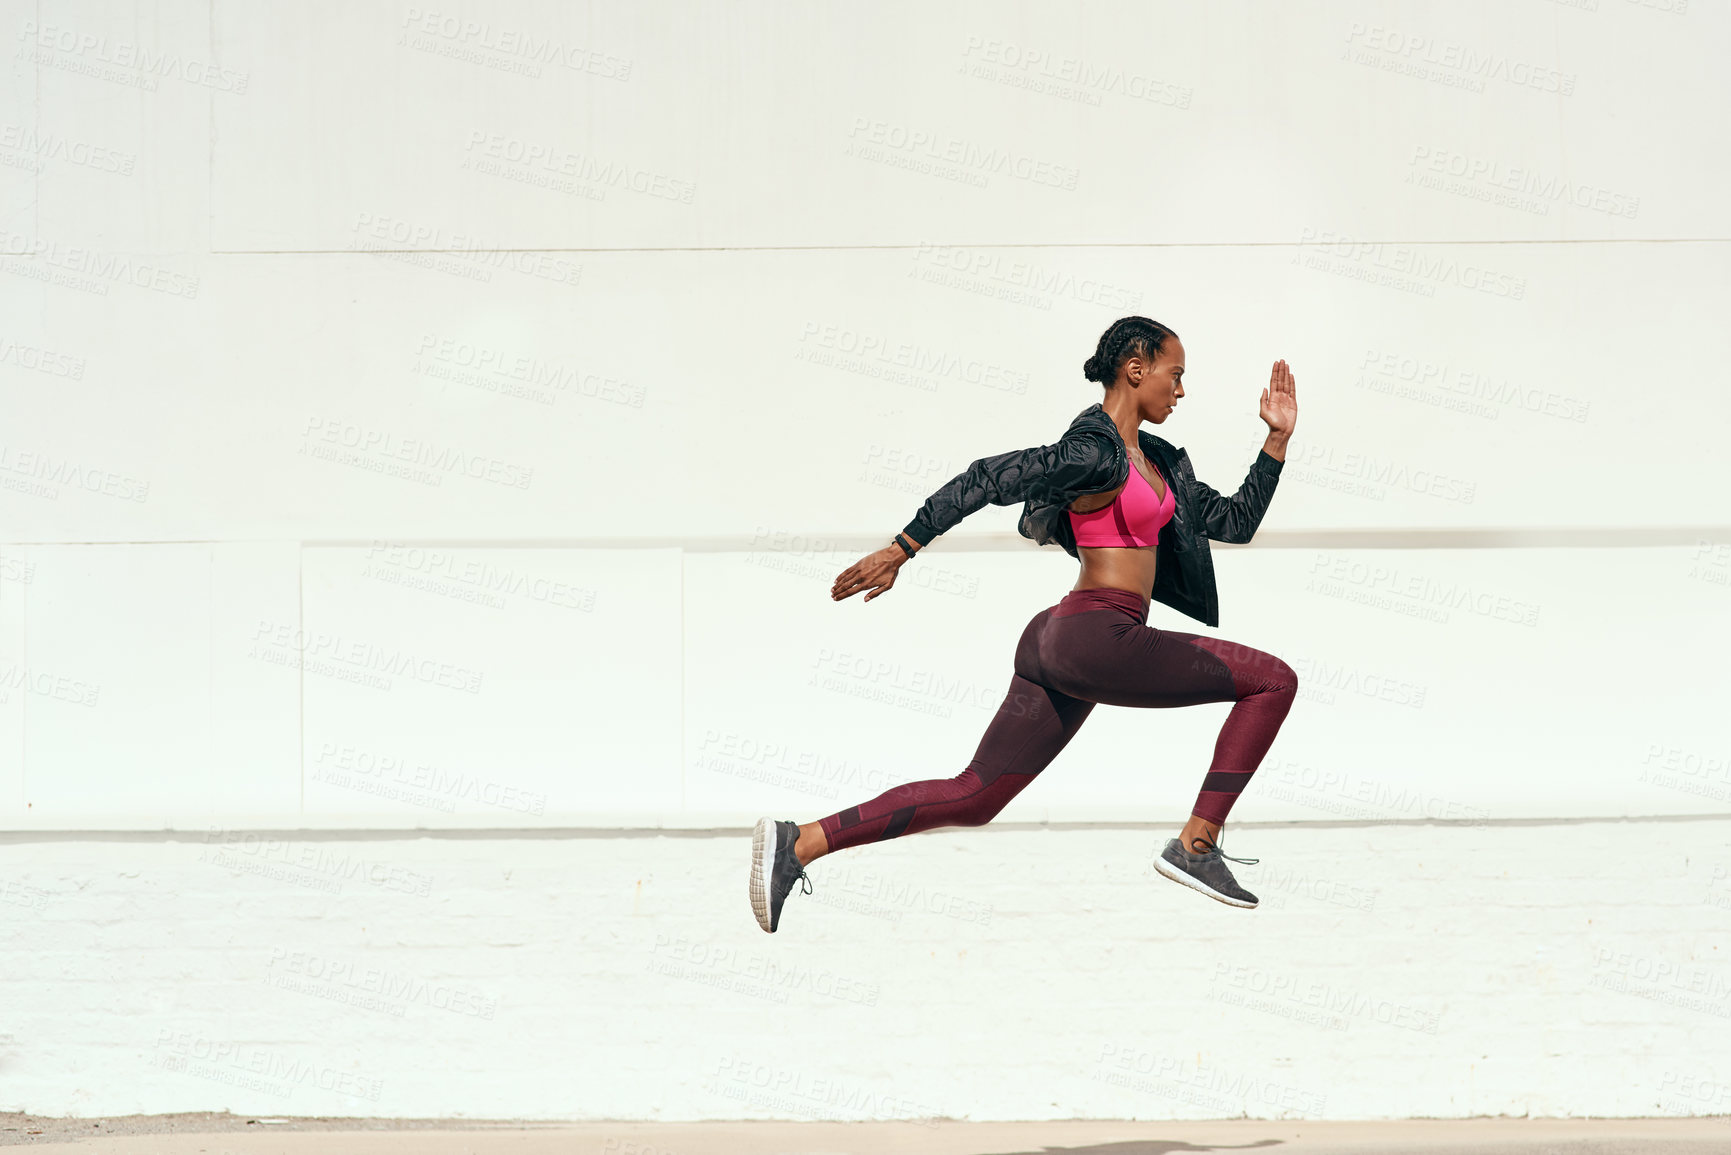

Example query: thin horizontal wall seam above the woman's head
[209,237,1731,256]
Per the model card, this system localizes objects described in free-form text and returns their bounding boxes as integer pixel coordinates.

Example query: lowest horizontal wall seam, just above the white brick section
[0,814,1731,843]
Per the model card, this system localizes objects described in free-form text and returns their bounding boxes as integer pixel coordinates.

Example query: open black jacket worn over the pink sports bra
[904,402,1283,625]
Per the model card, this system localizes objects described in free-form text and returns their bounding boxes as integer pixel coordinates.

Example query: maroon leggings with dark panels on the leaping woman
[819,589,1298,850]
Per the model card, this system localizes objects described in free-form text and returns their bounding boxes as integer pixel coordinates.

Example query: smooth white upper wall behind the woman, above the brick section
[0,0,1731,828]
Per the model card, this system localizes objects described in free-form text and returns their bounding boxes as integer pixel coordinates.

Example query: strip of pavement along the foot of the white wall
[0,1113,1731,1155]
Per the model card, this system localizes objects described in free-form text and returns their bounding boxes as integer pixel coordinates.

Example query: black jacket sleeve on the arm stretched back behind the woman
[902,429,1113,545]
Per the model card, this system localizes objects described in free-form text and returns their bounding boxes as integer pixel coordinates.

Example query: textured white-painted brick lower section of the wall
[0,819,1731,1120]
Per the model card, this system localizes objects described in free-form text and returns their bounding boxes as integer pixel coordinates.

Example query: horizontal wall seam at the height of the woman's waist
[0,525,1731,554]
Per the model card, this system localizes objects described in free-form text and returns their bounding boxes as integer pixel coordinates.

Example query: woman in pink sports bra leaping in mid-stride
[751,317,1298,932]
